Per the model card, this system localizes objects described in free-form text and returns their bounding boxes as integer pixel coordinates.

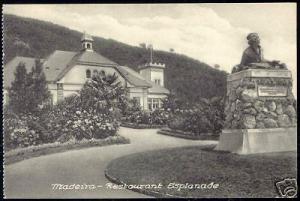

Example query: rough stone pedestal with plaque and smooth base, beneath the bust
[216,34,297,154]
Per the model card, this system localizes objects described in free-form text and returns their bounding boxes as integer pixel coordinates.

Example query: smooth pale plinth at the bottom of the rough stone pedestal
[215,127,297,154]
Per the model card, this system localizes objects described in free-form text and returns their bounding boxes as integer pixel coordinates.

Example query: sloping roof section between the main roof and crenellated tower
[116,66,151,87]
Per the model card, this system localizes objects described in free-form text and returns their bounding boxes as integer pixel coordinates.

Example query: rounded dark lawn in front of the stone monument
[106,147,297,198]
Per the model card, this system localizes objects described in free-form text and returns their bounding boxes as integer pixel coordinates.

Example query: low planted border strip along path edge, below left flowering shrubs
[4,135,130,165]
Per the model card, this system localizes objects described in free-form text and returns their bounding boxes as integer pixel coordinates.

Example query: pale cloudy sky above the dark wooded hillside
[3,3,297,96]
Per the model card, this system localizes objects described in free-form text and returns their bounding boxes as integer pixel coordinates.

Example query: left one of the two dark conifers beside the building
[8,63,28,113]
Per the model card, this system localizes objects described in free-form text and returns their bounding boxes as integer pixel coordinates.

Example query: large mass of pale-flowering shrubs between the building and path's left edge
[4,74,126,149]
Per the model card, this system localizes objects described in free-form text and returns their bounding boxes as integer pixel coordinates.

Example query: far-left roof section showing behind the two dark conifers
[3,56,35,88]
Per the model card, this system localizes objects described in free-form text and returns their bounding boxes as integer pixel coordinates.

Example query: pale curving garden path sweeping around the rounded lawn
[5,127,217,198]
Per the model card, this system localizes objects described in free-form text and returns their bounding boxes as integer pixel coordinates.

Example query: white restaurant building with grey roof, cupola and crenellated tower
[4,34,169,110]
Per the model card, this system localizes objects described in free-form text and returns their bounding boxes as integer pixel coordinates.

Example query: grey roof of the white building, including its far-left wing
[4,50,169,94]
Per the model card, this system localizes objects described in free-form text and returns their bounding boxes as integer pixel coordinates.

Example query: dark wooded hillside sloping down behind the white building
[3,15,226,103]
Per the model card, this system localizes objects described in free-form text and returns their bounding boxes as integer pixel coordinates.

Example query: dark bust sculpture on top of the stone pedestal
[232,33,287,73]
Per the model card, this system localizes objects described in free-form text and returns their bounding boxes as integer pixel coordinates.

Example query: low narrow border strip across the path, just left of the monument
[157,128,219,140]
